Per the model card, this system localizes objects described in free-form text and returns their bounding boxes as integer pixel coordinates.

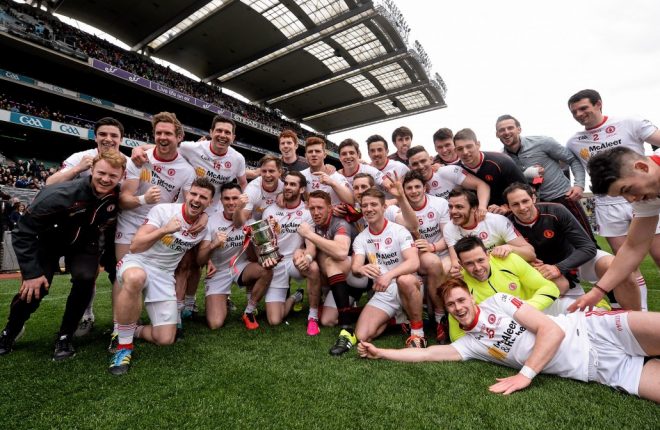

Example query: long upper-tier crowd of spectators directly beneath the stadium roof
[0,4,338,152]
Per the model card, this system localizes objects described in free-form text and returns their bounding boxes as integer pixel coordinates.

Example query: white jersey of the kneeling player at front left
[118,203,206,274]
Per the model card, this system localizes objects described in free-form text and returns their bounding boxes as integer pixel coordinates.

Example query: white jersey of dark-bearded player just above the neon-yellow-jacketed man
[443,212,520,251]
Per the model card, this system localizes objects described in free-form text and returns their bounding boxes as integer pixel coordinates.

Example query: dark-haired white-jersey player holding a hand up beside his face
[392,171,451,343]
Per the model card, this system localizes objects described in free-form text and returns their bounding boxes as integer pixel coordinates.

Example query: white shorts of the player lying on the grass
[586,311,646,395]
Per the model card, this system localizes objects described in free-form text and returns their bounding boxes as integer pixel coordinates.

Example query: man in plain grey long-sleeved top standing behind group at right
[495,115,596,244]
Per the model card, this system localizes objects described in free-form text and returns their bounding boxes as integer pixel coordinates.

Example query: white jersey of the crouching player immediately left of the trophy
[204,210,254,270]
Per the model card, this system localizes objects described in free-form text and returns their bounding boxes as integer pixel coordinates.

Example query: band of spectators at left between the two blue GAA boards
[0,93,151,142]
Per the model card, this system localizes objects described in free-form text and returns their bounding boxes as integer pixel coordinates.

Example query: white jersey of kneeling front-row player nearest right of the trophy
[353,220,414,274]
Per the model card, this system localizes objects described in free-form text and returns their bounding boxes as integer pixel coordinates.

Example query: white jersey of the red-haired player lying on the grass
[451,293,590,381]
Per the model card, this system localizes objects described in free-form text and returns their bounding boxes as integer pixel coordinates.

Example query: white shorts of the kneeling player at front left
[117,254,176,303]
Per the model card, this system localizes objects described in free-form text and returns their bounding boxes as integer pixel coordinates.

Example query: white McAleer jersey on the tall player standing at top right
[566,116,658,206]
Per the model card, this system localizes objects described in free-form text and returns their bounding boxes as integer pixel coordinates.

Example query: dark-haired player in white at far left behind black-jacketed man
[46,117,124,336]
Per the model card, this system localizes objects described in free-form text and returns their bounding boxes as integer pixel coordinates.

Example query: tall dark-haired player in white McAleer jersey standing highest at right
[566,90,660,307]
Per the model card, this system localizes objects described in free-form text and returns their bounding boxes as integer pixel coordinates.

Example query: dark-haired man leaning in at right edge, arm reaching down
[571,147,660,310]
